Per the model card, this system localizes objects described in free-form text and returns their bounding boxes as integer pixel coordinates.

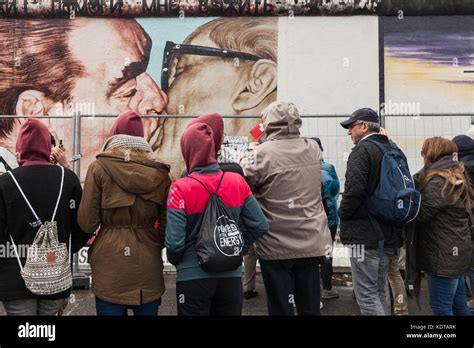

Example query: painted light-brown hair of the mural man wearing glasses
[183,17,278,63]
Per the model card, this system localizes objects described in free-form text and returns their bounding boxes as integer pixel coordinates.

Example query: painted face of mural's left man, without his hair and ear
[64,19,167,149]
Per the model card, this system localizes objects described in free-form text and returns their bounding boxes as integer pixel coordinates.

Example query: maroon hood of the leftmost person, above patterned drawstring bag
[16,119,51,166]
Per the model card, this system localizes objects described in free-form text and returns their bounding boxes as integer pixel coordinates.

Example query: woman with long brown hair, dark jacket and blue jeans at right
[414,137,474,316]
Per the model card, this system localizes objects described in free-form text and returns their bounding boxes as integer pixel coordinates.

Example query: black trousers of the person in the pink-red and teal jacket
[176,277,243,315]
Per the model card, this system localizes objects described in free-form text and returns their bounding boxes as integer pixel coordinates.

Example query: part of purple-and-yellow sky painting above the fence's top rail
[384,16,474,114]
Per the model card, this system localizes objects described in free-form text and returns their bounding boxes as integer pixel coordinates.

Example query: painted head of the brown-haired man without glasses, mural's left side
[0,18,167,177]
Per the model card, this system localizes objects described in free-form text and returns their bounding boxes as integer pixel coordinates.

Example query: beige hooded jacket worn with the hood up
[243,102,332,260]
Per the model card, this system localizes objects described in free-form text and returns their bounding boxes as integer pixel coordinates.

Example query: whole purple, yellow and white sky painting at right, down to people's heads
[384,16,474,171]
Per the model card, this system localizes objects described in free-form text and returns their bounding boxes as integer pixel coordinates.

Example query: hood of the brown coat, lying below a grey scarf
[97,149,170,196]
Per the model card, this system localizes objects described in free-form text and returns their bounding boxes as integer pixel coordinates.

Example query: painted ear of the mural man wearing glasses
[232,59,277,111]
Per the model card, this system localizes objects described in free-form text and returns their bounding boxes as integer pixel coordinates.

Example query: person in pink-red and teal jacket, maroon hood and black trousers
[166,122,268,315]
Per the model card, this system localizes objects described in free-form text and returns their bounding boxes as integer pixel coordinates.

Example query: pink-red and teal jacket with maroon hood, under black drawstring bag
[166,123,268,281]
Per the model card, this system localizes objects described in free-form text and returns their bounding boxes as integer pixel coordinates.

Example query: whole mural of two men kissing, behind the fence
[0,17,278,176]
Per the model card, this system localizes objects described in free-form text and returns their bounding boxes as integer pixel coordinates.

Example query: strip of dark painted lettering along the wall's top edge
[0,0,379,18]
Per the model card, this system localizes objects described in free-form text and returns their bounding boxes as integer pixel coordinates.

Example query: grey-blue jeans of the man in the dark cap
[350,250,391,315]
